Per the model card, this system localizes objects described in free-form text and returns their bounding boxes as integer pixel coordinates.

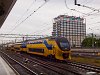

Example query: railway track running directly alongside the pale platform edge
[0,51,38,75]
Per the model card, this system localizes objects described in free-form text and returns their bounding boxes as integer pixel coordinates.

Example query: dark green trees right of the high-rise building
[82,37,100,47]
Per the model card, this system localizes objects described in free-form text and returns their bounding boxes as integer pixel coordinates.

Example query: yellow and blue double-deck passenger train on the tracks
[6,37,71,60]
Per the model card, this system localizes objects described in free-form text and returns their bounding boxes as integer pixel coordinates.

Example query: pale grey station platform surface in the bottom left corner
[0,56,16,75]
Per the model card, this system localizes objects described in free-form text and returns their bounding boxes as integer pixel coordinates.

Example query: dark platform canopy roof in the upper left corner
[0,0,17,27]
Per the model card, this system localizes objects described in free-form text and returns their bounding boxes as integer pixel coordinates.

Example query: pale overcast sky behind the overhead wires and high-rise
[0,0,100,41]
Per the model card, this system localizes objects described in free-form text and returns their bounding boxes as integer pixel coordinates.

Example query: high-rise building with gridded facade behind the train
[52,15,86,47]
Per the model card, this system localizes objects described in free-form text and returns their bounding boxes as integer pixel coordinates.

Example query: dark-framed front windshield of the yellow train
[56,38,70,51]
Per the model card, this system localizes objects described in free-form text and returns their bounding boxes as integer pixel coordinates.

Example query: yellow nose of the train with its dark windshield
[56,37,71,60]
